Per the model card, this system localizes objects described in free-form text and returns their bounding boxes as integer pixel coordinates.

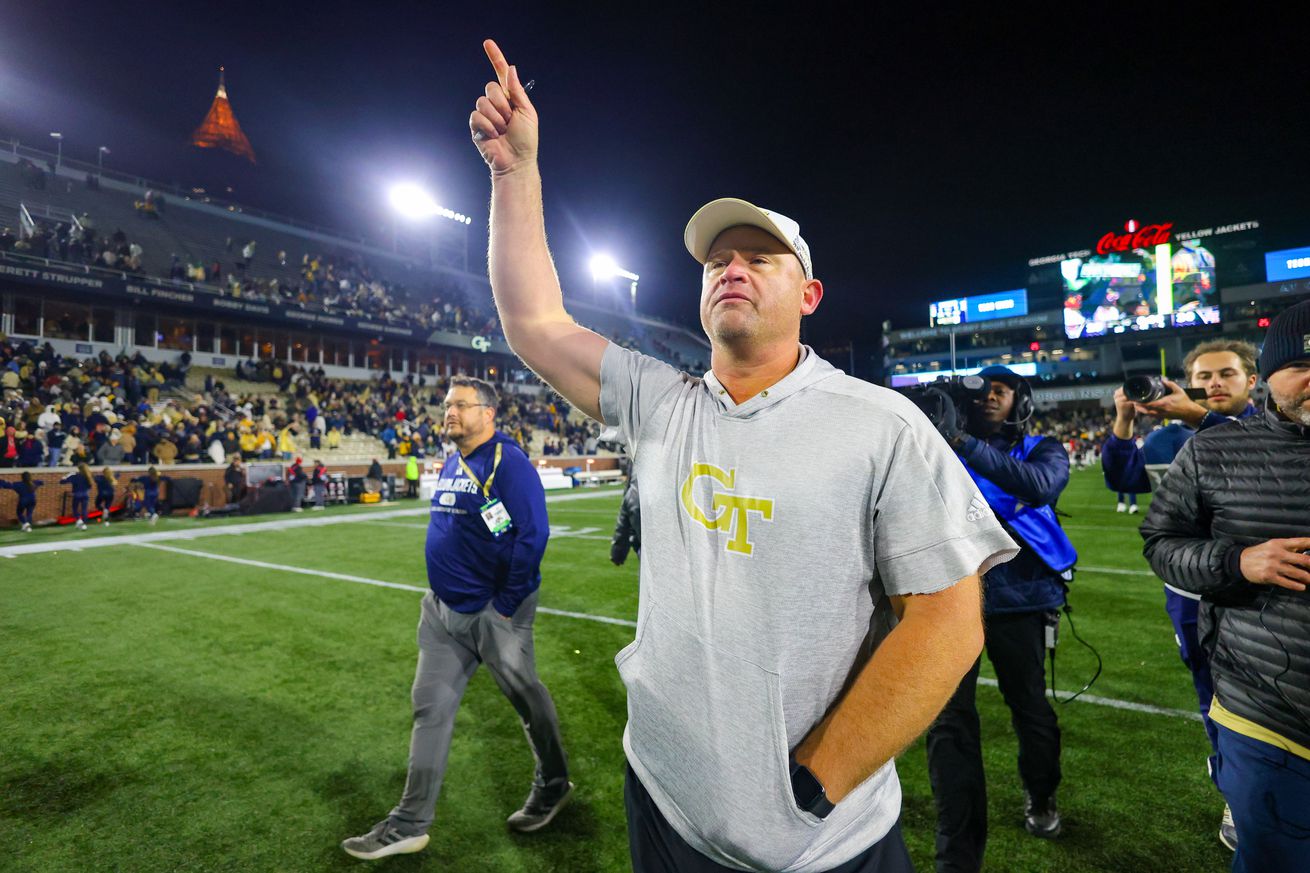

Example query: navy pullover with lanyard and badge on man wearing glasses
[427,430,550,617]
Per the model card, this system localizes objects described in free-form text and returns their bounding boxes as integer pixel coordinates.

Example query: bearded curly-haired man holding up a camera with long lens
[1100,340,1256,849]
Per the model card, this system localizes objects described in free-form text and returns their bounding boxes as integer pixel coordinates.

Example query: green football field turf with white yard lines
[0,469,1230,873]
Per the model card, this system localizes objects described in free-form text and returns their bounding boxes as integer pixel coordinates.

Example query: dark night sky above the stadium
[0,0,1310,343]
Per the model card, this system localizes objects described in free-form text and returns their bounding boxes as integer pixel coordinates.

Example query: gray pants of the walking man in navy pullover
[390,591,569,835]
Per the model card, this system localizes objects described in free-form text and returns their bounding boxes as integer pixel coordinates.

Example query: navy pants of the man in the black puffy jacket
[1216,725,1310,873]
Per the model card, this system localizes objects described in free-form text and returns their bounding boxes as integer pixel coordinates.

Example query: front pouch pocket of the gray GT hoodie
[616,612,820,869]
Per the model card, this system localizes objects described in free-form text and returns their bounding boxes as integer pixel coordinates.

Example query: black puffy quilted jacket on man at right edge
[1141,412,1310,746]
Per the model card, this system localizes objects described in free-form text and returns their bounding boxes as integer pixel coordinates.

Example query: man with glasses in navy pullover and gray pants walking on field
[342,376,572,860]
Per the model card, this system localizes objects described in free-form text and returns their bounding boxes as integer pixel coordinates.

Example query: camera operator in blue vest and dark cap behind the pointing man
[927,367,1078,873]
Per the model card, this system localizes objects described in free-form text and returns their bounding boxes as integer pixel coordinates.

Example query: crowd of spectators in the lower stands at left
[0,331,599,468]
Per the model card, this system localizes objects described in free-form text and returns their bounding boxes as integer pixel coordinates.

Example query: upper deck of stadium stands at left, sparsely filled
[0,146,709,376]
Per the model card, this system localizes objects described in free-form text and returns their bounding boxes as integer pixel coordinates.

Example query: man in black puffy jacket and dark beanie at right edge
[1141,301,1310,873]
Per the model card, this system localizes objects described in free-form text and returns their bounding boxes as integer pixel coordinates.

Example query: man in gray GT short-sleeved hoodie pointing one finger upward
[469,41,1017,873]
